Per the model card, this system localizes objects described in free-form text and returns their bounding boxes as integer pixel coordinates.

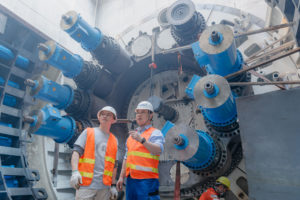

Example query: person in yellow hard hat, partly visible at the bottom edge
[199,176,230,200]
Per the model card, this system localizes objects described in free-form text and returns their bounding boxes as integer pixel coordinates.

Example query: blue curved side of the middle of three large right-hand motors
[199,94,237,126]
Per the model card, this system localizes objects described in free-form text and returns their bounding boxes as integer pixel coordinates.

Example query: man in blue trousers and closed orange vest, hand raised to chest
[117,101,165,200]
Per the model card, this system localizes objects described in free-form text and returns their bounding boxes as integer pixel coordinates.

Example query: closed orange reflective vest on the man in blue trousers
[126,127,159,179]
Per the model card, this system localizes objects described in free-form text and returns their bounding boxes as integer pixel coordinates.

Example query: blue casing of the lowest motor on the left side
[30,105,76,143]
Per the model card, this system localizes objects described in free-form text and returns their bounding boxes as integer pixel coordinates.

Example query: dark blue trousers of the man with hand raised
[126,176,160,200]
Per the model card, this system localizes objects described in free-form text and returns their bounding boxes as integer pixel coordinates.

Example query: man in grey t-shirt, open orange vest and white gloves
[70,106,118,200]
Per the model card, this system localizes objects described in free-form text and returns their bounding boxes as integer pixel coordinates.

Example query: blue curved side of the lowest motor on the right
[182,130,216,170]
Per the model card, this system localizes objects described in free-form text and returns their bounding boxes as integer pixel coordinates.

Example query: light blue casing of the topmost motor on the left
[65,14,103,51]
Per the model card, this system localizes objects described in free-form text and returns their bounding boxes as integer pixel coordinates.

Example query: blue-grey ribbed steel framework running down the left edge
[0,7,48,200]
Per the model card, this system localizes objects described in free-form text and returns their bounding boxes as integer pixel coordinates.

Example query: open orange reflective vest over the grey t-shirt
[78,128,118,186]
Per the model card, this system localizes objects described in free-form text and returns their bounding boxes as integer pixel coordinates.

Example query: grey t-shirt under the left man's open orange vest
[74,127,118,190]
